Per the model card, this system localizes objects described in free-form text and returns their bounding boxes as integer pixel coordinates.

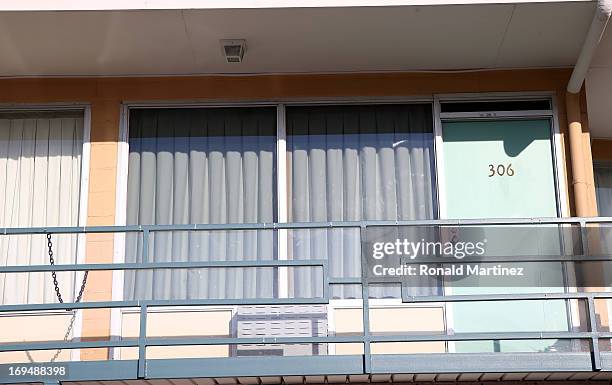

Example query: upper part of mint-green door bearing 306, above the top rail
[443,119,557,218]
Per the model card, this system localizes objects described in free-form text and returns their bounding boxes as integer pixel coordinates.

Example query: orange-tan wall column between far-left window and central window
[81,100,120,360]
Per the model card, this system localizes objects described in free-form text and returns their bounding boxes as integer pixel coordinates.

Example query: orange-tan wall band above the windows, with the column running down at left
[0,69,590,359]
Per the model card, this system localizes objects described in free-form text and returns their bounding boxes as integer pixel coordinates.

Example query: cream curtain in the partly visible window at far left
[0,111,83,304]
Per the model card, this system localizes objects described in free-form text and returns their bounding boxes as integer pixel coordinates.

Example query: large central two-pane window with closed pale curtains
[124,104,436,299]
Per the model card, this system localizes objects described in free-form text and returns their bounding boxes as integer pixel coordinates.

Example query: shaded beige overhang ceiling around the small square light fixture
[0,1,594,76]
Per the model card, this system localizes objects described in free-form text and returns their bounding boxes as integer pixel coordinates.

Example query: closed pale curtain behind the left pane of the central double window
[124,108,276,299]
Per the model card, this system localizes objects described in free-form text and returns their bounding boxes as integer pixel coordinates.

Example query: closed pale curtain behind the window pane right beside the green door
[287,104,435,298]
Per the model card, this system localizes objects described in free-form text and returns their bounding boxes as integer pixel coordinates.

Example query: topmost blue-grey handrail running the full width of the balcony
[0,217,612,235]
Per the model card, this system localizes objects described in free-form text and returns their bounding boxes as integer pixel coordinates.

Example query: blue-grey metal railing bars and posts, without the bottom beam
[0,218,612,378]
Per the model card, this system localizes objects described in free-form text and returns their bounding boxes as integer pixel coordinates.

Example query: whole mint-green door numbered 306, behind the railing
[442,119,568,352]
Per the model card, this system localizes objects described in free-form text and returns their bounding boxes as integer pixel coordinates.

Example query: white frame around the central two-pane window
[111,96,444,359]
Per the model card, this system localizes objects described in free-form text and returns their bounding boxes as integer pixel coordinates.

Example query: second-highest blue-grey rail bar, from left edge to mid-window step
[0,259,327,273]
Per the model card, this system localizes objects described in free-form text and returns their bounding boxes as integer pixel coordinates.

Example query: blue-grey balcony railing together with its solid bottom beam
[0,218,612,383]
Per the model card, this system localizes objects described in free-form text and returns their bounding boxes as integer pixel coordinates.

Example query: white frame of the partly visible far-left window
[0,103,91,361]
